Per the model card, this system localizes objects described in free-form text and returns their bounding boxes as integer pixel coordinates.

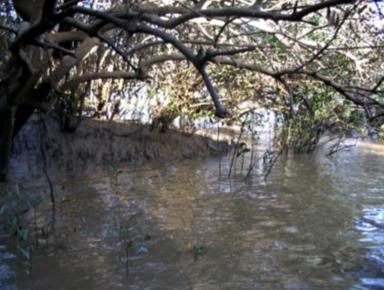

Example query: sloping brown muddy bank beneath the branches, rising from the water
[10,116,230,175]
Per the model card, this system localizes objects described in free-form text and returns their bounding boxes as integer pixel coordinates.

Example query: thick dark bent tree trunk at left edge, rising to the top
[0,0,100,180]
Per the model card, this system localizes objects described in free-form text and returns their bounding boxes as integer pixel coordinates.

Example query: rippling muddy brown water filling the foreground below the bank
[0,143,384,290]
